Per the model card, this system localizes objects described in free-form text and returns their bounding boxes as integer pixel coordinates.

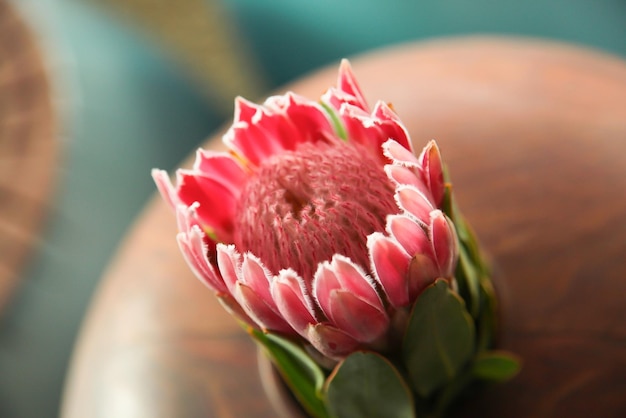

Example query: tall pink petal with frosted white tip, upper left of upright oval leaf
[367,232,411,307]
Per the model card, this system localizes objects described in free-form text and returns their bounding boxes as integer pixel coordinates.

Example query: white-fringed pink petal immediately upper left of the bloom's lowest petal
[271,270,318,338]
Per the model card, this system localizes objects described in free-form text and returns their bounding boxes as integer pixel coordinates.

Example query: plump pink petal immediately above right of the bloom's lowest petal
[329,290,389,343]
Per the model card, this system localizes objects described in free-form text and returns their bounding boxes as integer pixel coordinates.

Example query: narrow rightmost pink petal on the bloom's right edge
[430,210,458,278]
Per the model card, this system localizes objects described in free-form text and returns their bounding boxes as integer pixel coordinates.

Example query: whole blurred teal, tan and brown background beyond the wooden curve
[0,0,626,418]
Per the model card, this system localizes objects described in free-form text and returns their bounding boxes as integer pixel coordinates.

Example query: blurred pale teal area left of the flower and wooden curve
[0,0,223,418]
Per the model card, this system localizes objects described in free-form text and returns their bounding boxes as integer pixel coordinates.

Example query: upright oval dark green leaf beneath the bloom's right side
[402,280,475,398]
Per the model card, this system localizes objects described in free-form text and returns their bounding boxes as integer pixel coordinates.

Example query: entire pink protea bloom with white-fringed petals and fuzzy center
[153,60,457,359]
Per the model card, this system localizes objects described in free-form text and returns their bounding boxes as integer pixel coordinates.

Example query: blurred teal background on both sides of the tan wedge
[0,0,626,418]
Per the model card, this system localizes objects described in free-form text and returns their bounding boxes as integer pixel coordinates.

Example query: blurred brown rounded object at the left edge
[0,0,58,314]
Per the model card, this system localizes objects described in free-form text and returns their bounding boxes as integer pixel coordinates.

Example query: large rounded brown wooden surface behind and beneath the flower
[62,38,626,418]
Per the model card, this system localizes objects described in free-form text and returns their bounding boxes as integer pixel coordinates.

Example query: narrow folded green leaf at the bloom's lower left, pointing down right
[250,329,328,418]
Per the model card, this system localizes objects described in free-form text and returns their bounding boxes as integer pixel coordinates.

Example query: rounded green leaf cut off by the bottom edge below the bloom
[327,351,415,418]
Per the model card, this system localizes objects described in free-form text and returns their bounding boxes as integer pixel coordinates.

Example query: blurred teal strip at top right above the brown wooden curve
[226,0,626,85]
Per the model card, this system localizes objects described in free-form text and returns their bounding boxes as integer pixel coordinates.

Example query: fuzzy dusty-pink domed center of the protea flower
[234,141,398,282]
